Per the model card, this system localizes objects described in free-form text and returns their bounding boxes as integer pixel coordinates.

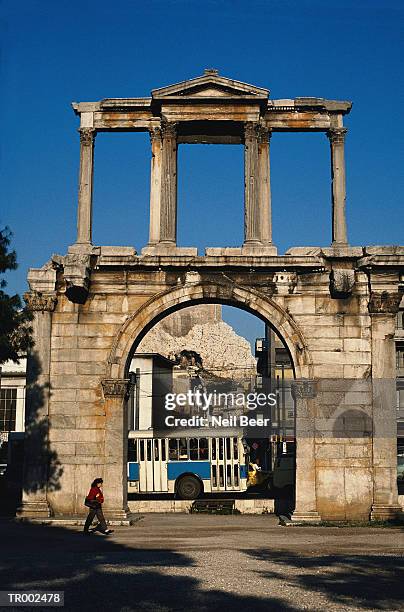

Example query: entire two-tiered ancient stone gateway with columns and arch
[20,70,404,521]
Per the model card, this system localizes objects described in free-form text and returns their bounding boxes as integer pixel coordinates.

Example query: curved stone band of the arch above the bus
[108,280,312,379]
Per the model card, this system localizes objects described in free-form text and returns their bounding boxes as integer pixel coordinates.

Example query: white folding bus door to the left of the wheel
[139,438,168,493]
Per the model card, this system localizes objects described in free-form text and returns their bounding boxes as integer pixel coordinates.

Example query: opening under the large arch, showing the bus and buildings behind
[125,297,296,513]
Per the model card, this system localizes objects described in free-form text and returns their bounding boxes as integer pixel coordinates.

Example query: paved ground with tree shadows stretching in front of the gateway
[0,514,404,612]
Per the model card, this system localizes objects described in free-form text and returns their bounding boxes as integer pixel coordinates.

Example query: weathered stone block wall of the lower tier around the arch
[22,249,404,520]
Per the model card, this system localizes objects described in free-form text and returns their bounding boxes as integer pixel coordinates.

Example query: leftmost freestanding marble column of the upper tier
[76,128,96,245]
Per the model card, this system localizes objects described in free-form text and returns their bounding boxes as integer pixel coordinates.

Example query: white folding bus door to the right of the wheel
[210,436,240,491]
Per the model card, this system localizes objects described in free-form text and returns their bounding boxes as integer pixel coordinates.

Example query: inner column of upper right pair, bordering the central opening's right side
[244,122,261,247]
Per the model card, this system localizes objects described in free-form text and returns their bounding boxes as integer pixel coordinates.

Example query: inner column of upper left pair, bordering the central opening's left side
[160,122,177,247]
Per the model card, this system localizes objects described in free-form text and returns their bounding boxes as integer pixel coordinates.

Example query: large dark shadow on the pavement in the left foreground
[0,520,296,612]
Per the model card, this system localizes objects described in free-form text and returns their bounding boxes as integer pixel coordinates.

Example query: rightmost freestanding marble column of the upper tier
[327,128,348,246]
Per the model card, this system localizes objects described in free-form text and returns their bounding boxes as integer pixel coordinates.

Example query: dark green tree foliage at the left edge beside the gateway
[0,227,32,363]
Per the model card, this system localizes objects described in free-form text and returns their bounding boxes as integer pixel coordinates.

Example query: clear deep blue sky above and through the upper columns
[0,0,404,344]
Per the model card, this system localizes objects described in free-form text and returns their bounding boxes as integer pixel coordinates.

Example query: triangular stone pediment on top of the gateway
[152,70,269,100]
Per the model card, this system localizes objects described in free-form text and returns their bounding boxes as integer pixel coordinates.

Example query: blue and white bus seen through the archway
[128,431,248,499]
